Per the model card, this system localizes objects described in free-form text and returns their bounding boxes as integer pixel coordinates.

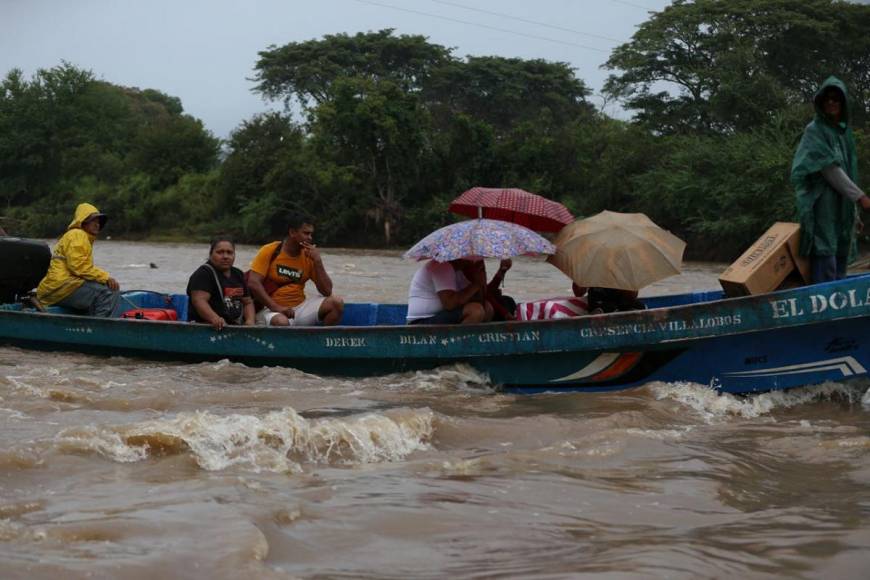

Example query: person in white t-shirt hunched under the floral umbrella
[407,259,492,324]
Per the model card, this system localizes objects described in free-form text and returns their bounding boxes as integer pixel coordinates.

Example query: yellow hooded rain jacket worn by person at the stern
[36,203,109,306]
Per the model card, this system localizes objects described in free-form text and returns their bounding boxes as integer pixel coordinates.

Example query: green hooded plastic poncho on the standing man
[791,76,858,257]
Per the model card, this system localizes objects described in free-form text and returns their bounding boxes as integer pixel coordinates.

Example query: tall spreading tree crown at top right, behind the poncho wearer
[605,0,870,133]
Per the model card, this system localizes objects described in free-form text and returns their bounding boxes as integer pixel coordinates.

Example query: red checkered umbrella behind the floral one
[449,187,574,232]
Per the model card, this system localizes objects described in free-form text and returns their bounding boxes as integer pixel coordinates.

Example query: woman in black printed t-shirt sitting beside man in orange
[187,236,255,330]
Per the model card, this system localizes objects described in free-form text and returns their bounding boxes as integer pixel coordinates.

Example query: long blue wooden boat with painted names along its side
[0,275,870,393]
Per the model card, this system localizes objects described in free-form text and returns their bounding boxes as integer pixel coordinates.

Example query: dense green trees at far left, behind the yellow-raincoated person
[0,63,219,235]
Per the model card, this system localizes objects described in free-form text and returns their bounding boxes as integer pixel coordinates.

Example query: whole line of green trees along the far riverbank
[0,0,870,259]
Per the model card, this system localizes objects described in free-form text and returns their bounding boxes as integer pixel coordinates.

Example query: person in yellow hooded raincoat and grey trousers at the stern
[36,203,121,317]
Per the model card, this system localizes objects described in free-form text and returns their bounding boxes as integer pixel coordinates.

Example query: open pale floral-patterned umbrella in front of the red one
[405,219,556,262]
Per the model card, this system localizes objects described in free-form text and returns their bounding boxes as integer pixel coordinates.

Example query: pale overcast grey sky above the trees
[0,0,670,138]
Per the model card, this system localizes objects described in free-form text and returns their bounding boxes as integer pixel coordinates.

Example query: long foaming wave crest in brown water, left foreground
[55,408,434,472]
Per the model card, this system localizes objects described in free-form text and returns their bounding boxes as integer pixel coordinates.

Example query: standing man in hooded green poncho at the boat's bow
[791,76,870,284]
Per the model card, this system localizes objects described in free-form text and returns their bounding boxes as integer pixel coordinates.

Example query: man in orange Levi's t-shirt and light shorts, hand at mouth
[248,213,344,326]
